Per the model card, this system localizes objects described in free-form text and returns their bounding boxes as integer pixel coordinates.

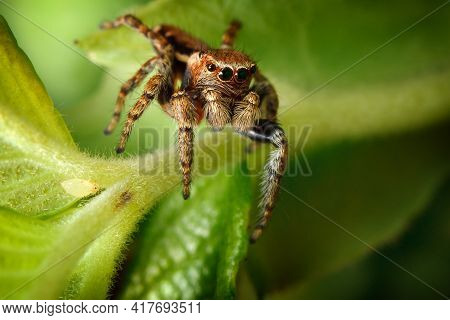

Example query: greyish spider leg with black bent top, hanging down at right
[241,119,288,242]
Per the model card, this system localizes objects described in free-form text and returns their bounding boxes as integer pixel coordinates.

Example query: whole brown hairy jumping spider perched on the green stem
[101,15,287,241]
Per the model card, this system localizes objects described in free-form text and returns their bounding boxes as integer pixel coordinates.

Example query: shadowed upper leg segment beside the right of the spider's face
[251,72,278,122]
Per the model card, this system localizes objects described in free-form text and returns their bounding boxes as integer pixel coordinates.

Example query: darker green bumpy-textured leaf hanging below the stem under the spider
[122,166,251,299]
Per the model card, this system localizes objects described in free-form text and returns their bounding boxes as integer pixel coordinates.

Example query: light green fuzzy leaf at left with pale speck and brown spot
[0,15,178,299]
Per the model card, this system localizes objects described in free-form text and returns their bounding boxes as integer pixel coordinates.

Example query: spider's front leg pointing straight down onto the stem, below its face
[170,91,197,199]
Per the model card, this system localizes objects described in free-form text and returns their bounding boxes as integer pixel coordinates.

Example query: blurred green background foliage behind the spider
[0,0,450,299]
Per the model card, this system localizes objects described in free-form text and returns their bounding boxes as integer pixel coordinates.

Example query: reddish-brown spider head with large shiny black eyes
[188,49,256,95]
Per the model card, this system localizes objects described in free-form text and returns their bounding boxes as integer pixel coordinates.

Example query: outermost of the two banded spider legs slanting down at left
[103,57,159,134]
